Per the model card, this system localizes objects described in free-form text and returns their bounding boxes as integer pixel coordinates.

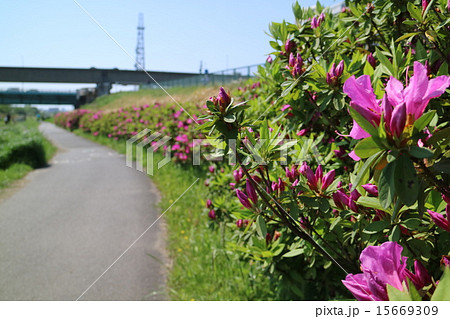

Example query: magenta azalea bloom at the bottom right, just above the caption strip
[342,242,407,301]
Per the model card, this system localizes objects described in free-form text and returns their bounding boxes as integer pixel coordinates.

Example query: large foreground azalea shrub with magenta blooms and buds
[201,0,450,300]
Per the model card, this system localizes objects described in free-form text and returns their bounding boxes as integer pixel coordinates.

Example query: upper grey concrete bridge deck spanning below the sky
[0,67,198,96]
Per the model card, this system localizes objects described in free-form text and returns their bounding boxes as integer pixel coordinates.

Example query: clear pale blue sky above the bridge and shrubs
[0,0,339,96]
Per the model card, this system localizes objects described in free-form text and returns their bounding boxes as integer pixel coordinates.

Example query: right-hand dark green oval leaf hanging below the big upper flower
[394,154,419,206]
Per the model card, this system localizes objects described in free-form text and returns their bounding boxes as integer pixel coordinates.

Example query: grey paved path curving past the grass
[0,123,166,300]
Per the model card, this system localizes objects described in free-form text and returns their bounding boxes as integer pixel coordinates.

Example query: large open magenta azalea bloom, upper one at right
[344,61,450,139]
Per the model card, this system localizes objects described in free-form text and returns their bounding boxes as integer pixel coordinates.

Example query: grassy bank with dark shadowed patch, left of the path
[0,119,56,191]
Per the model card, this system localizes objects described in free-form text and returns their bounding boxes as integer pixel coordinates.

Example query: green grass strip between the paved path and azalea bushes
[75,130,274,300]
